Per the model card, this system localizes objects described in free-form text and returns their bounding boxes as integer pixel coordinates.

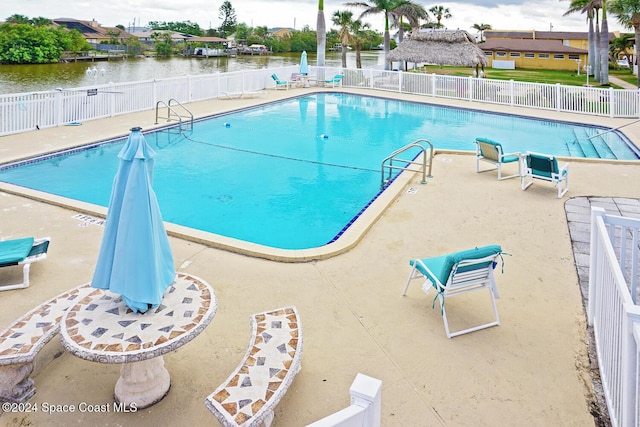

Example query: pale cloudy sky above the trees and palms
[0,0,631,34]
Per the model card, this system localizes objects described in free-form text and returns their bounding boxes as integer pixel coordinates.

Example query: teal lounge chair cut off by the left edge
[0,237,51,291]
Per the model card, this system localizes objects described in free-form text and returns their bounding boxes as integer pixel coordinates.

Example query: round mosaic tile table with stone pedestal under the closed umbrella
[60,273,217,409]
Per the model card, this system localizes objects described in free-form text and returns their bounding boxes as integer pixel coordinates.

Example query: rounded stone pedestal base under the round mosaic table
[114,356,171,409]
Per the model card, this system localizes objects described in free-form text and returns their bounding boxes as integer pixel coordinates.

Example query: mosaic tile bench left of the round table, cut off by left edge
[0,283,92,403]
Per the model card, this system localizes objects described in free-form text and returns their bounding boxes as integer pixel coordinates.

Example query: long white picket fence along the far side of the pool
[0,66,640,136]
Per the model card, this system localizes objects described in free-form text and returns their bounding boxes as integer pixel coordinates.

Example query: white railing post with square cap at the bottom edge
[307,374,382,427]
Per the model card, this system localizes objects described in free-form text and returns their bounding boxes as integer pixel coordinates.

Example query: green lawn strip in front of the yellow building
[416,65,637,88]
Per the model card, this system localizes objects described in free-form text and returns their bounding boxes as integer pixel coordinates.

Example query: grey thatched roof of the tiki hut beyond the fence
[388,30,489,67]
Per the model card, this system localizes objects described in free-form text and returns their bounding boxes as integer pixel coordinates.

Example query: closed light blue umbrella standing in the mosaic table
[91,127,175,313]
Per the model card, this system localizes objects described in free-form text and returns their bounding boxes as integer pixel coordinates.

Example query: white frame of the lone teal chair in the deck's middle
[402,253,500,338]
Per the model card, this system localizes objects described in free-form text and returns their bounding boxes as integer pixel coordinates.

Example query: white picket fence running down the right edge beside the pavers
[587,208,640,427]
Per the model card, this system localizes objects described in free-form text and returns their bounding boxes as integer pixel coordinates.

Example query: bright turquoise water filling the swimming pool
[0,93,638,249]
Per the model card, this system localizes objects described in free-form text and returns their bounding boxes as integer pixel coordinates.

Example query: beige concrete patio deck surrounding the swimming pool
[0,89,640,427]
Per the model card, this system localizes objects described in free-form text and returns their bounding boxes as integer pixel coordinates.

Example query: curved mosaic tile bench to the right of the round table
[205,306,302,427]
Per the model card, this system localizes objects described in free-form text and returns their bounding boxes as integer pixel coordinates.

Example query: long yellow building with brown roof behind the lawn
[478,30,616,71]
